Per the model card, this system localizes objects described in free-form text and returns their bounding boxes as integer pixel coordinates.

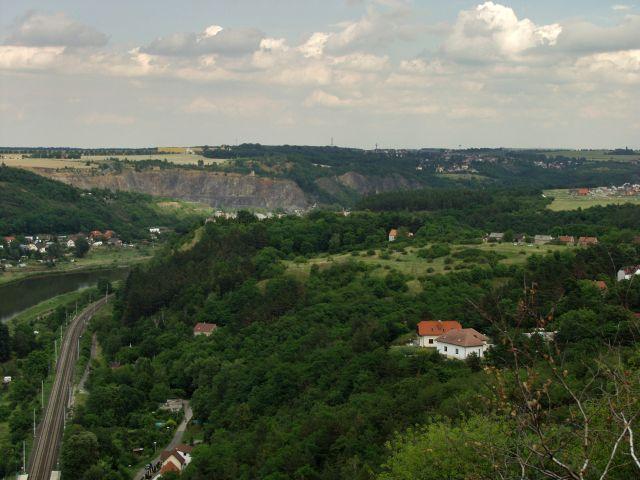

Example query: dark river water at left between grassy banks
[0,268,128,322]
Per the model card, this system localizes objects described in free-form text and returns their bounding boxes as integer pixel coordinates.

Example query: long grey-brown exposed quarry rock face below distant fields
[34,169,308,210]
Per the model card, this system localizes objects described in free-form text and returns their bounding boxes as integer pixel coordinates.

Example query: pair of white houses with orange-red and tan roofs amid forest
[417,320,491,360]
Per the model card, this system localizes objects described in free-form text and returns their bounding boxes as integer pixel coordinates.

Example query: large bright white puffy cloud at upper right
[443,2,562,62]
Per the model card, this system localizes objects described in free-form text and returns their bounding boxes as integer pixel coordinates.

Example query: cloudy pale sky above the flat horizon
[0,0,640,148]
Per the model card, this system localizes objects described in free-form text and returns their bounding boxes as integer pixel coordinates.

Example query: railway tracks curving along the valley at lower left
[27,298,106,480]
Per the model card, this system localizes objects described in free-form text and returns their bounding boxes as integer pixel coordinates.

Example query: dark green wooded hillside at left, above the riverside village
[0,166,196,240]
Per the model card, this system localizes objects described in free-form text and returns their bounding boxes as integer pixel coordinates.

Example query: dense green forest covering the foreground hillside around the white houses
[63,191,640,480]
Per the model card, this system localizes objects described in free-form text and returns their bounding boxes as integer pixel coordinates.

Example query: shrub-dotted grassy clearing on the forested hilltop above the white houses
[285,243,575,284]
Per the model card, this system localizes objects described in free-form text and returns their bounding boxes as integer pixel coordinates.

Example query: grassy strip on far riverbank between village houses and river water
[0,245,156,285]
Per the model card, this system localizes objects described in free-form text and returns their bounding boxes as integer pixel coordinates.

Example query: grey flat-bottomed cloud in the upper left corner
[5,11,107,47]
